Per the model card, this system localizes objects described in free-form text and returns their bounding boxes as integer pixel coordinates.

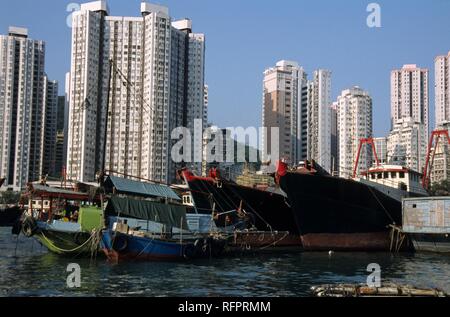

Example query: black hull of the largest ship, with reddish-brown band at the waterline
[280,173,402,250]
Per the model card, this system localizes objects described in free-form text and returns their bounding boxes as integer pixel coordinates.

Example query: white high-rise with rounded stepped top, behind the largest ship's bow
[337,87,372,178]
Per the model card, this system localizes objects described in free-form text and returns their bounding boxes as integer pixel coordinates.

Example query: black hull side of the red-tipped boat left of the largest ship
[188,179,299,235]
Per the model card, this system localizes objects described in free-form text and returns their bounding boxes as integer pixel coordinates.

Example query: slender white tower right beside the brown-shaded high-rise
[307,69,332,172]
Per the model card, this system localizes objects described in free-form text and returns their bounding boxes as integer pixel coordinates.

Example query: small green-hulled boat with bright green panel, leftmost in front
[15,184,104,257]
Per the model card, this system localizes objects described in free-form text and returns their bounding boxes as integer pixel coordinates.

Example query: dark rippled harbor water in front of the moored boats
[0,228,450,297]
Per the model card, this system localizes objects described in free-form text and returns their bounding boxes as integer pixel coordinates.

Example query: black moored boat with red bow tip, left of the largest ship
[181,169,301,250]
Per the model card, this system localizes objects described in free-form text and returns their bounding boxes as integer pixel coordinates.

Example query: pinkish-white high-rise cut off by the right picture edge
[434,52,450,127]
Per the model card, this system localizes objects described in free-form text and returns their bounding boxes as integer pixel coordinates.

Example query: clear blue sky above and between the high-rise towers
[0,0,450,136]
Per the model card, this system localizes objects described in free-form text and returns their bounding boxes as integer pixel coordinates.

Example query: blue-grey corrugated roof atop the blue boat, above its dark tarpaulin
[105,176,181,200]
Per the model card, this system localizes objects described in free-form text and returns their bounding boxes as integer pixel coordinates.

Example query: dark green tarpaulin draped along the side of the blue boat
[106,196,188,229]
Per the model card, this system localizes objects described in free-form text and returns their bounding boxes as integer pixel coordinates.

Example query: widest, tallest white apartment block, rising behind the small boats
[67,1,205,183]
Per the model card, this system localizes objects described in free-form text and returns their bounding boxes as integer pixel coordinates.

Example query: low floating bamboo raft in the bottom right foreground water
[311,283,450,297]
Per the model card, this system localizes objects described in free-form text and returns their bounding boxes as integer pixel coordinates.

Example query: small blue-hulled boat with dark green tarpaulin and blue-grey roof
[98,176,225,261]
